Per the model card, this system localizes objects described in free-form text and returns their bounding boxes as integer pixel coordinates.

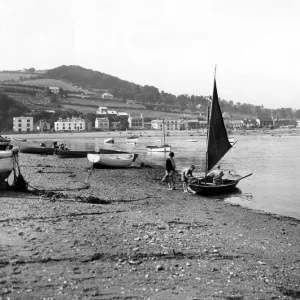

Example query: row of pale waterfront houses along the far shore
[13,110,300,132]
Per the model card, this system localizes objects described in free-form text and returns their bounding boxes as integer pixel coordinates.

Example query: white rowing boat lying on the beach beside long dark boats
[87,153,138,168]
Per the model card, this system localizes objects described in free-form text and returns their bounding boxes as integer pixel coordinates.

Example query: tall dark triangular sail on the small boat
[207,79,231,171]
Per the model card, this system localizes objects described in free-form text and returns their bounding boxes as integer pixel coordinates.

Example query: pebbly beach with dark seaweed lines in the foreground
[0,154,300,300]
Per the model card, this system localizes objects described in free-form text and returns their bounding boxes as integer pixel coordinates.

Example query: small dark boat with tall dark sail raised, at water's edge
[188,74,252,194]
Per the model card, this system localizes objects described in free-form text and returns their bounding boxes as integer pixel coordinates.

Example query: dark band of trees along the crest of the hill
[44,65,300,119]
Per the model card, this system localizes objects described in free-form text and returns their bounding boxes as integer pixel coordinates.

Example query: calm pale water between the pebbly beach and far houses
[18,131,300,219]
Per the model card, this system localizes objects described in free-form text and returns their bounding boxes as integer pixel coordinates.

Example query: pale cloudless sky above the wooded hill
[0,0,300,109]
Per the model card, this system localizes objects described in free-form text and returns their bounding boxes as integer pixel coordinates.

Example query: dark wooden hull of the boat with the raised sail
[188,179,239,195]
